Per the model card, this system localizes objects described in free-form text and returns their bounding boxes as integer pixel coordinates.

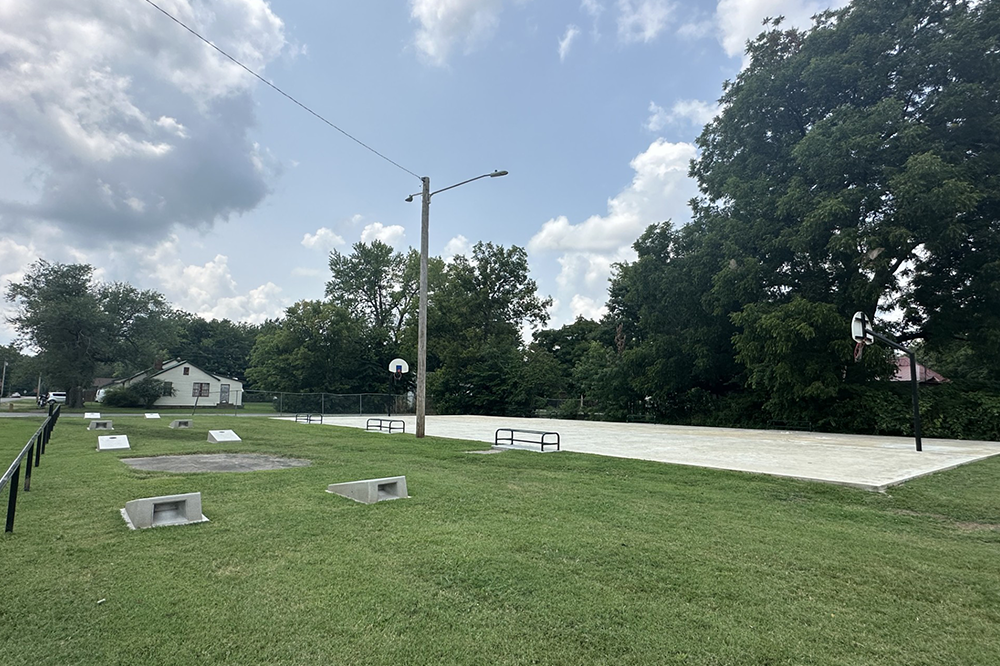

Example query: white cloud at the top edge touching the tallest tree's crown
[715,0,848,57]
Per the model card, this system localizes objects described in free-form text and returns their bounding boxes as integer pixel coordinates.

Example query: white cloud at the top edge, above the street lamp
[410,0,503,66]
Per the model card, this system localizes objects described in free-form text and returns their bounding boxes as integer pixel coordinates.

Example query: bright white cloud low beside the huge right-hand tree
[528,139,697,252]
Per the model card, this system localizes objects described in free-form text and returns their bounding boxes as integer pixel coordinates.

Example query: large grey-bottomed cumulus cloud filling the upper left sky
[0,0,285,245]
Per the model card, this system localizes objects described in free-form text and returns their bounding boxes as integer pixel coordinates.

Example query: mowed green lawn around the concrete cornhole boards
[0,416,1000,666]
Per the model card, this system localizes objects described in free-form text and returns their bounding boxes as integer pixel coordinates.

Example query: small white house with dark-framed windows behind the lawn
[97,359,243,408]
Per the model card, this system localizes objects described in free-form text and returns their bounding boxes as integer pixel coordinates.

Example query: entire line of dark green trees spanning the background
[7,0,1000,439]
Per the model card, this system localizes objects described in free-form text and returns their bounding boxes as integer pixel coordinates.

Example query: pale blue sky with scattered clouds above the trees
[0,0,844,343]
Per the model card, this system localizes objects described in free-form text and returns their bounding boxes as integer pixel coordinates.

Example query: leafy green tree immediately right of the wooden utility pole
[427,242,552,414]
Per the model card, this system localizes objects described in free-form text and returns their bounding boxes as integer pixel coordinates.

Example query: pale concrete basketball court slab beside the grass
[300,415,1000,490]
